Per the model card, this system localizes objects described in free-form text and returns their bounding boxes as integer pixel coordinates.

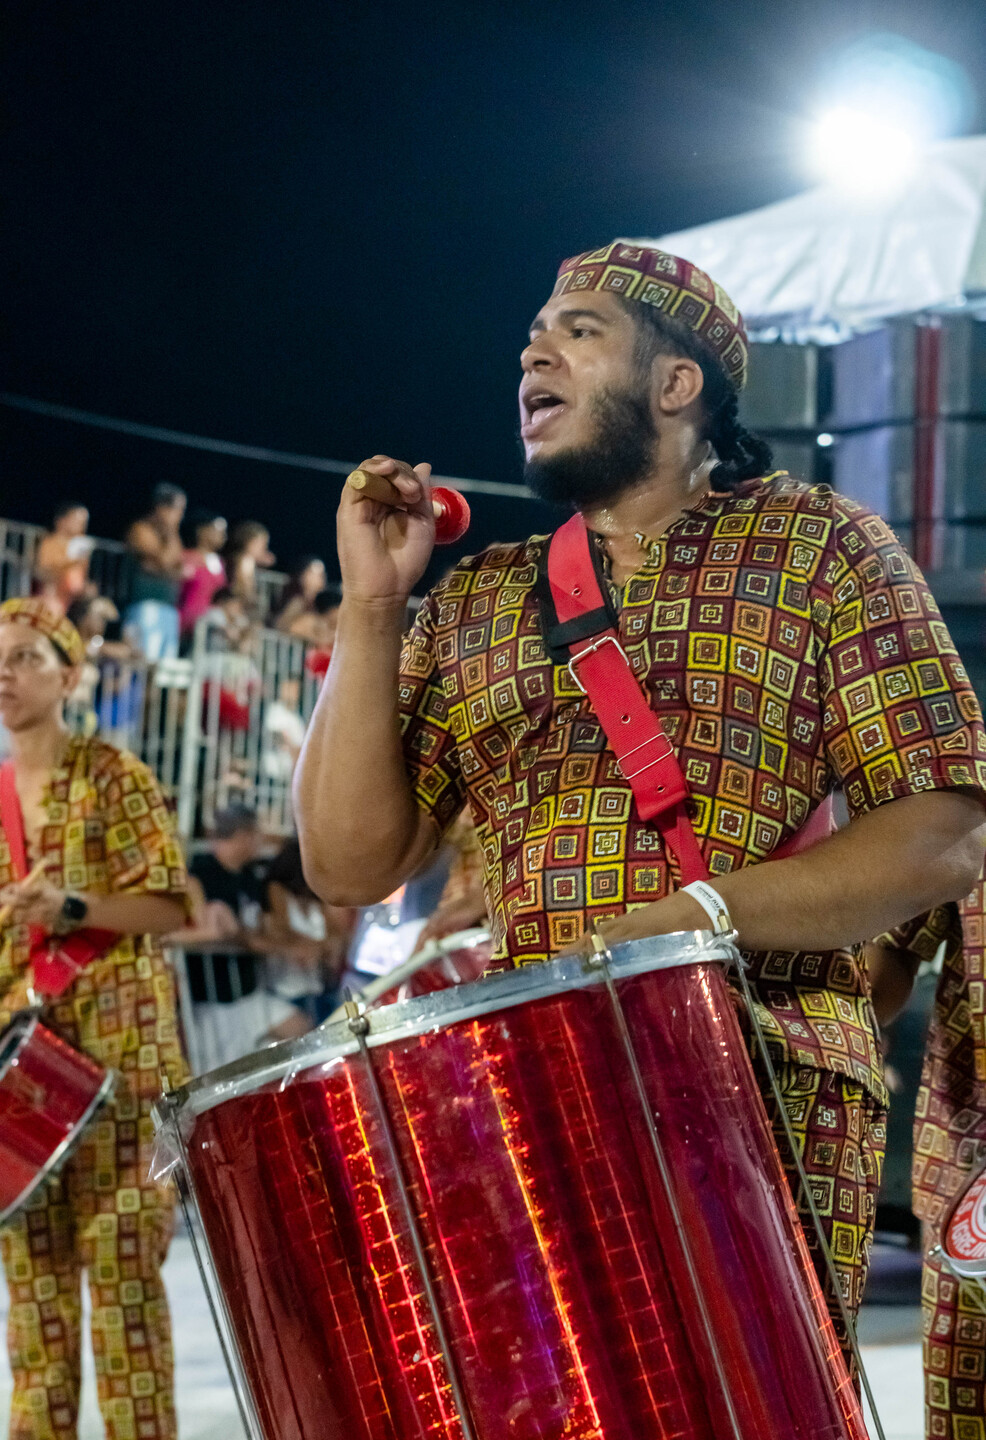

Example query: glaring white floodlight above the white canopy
[812,105,923,193]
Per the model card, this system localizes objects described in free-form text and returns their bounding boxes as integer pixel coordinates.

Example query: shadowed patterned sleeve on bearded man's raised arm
[397,589,466,831]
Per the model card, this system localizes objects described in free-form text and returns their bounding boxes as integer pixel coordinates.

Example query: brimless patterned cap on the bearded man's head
[554,240,750,390]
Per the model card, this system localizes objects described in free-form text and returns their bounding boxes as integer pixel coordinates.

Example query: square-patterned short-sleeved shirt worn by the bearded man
[400,472,986,1097]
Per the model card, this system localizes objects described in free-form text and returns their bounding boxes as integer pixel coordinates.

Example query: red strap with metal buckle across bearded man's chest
[548,514,708,886]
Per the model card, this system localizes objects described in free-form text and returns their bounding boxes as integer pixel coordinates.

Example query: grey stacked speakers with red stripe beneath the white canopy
[741,312,986,578]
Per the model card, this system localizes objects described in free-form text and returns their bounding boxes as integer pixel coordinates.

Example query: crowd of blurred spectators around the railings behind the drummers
[9,485,485,1070]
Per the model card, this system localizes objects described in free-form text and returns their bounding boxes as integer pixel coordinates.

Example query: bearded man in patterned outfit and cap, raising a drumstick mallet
[295,242,986,1365]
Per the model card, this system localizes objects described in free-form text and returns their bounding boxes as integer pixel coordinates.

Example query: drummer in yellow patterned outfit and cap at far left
[0,600,186,1440]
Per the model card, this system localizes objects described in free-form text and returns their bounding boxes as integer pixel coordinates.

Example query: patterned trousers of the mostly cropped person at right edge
[921,1259,986,1440]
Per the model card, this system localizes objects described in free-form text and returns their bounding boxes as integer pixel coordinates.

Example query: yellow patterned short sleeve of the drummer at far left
[96,750,189,897]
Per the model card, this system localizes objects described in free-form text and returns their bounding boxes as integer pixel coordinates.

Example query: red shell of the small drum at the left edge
[0,1011,112,1224]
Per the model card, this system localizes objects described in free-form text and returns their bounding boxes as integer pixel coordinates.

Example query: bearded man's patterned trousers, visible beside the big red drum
[754,1061,887,1377]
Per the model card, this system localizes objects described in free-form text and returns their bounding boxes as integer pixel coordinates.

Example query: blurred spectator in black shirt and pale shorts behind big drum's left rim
[171,805,303,1068]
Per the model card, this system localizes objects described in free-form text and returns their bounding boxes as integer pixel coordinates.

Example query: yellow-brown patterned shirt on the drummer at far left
[0,737,186,1088]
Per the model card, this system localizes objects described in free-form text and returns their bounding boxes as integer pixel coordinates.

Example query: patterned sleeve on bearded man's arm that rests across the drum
[816,497,986,815]
